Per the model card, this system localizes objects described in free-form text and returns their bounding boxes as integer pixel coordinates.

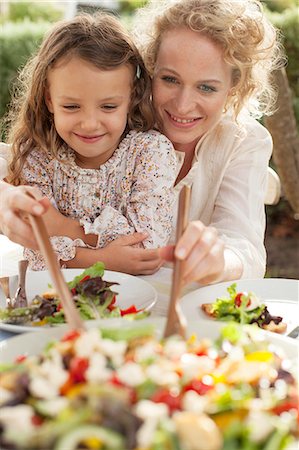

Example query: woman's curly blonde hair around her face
[133,0,285,118]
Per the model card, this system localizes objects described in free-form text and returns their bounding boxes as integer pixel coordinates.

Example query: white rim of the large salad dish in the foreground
[0,317,299,363]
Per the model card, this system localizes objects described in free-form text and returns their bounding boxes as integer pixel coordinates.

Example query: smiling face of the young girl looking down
[46,57,132,169]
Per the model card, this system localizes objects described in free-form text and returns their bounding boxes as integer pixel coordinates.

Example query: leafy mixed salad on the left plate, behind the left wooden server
[0,262,149,326]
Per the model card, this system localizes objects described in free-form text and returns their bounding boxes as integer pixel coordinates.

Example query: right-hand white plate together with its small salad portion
[181,278,299,334]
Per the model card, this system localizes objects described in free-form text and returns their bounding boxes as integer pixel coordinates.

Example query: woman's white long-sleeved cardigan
[0,112,272,278]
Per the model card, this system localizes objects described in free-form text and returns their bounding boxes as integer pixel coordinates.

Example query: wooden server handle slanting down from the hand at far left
[28,214,85,330]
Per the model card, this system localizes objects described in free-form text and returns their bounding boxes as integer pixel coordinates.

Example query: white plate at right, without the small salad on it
[180,278,299,333]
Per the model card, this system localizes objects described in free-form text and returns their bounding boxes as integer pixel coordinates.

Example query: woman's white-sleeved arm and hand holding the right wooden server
[161,119,272,284]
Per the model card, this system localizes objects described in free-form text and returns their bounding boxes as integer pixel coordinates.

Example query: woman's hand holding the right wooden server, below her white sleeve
[160,221,225,284]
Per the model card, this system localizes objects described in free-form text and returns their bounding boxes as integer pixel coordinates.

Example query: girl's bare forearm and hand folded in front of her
[67,233,163,275]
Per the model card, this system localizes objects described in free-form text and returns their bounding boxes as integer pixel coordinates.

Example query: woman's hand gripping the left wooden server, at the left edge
[0,181,50,250]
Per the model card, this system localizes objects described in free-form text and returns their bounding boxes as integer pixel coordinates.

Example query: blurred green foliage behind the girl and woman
[0,0,299,134]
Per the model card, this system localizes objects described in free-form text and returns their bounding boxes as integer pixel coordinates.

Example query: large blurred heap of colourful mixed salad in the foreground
[0,324,298,450]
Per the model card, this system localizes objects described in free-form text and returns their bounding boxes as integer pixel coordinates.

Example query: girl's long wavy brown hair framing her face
[6,13,154,185]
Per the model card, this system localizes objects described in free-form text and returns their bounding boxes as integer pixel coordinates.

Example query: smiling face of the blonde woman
[153,28,232,152]
